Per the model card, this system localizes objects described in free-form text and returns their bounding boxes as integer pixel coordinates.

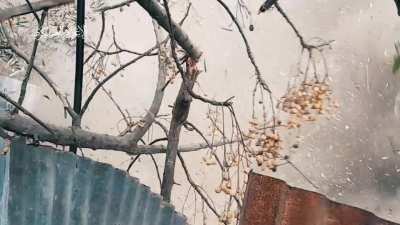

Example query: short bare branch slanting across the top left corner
[0,0,74,22]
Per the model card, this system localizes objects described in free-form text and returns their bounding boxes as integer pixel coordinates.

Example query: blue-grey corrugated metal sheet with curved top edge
[0,141,186,225]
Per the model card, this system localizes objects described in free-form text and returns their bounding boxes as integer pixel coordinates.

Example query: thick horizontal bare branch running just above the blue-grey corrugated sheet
[0,112,230,155]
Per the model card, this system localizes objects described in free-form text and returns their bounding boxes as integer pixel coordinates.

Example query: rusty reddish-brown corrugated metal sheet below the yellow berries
[240,172,398,225]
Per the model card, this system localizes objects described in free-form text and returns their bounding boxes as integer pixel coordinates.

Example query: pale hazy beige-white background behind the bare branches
[0,0,400,224]
